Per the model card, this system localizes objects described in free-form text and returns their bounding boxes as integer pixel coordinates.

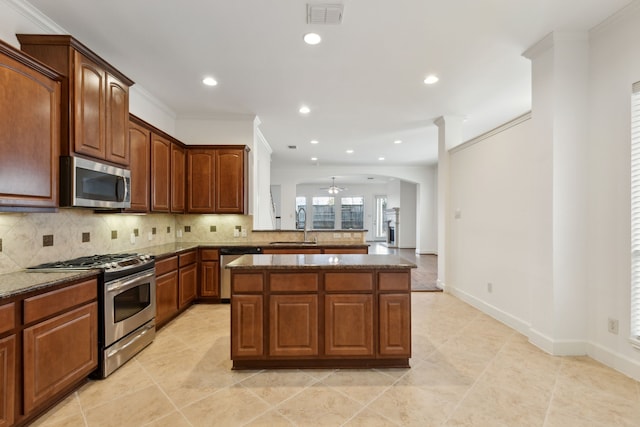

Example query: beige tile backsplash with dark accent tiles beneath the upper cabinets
[0,209,253,274]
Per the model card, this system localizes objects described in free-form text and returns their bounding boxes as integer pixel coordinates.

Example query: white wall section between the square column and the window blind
[585,2,640,378]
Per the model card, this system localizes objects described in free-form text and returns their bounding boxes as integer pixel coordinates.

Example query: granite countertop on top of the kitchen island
[227,254,417,270]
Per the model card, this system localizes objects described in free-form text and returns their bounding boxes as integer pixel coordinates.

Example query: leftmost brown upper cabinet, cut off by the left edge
[0,42,63,210]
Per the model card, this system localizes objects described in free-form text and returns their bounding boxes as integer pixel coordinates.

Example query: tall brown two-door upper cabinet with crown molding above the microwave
[17,34,133,166]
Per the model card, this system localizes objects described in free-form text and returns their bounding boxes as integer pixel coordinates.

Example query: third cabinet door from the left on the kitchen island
[324,294,374,357]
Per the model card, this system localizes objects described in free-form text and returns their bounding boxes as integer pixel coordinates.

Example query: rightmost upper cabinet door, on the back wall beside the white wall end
[214,148,245,214]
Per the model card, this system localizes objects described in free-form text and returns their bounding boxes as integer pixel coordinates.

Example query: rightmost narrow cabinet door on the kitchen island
[379,293,411,357]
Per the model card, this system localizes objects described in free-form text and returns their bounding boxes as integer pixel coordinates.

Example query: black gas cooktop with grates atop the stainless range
[27,253,153,272]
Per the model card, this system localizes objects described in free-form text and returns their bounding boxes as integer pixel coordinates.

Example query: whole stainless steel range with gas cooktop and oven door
[29,254,156,378]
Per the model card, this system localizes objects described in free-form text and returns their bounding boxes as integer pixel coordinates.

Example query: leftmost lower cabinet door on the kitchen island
[231,295,264,359]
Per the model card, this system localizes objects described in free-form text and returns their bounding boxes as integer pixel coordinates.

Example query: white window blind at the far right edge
[630,82,640,348]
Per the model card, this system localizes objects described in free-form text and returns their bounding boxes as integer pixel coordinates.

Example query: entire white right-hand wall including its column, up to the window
[447,2,640,379]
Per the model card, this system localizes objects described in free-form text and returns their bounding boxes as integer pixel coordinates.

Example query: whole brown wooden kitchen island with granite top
[227,255,416,369]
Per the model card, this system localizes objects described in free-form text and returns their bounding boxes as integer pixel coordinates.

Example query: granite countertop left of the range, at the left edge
[0,270,100,299]
